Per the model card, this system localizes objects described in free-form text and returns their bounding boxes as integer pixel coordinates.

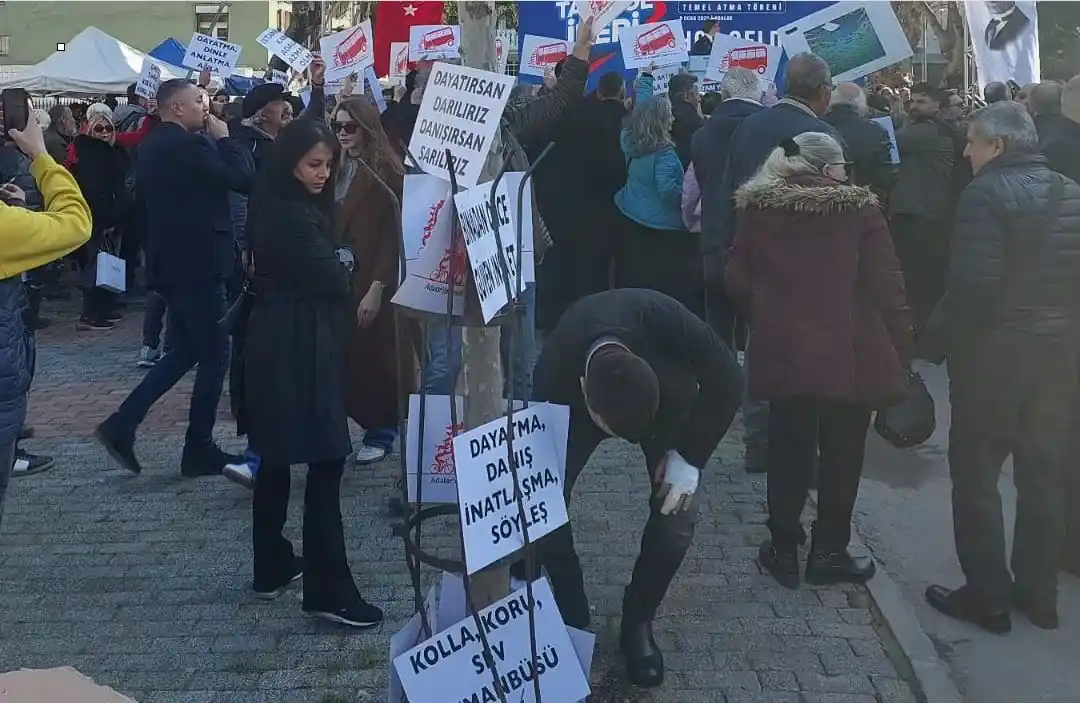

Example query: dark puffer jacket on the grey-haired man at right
[923,153,1080,360]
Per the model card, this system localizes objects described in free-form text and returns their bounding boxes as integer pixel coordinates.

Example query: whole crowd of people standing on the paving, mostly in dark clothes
[0,15,1080,686]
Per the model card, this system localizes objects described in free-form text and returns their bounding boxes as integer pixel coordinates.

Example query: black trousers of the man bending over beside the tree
[527,410,703,627]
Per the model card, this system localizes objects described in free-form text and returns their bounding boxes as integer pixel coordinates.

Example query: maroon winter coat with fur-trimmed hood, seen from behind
[725,176,913,408]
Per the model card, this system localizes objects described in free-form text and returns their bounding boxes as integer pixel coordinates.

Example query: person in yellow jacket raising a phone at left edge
[0,110,91,526]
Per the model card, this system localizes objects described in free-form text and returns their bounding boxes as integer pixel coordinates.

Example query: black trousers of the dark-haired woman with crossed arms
[252,458,360,609]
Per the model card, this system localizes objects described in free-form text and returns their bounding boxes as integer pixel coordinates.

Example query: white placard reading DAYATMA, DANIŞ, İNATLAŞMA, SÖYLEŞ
[454,406,569,573]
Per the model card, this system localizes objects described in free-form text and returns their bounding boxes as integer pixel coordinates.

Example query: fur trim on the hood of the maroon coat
[735,175,878,215]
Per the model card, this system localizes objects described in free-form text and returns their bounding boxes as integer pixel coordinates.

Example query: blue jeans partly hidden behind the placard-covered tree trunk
[423,283,537,400]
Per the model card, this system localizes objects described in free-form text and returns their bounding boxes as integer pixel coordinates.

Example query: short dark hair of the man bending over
[584,344,660,442]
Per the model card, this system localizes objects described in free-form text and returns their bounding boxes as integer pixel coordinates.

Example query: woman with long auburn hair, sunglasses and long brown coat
[330,96,413,464]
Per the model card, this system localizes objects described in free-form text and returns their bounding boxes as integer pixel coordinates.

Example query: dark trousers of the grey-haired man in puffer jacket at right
[948,357,1077,608]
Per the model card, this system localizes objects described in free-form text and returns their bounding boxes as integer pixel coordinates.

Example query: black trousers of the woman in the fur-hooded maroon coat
[768,397,870,553]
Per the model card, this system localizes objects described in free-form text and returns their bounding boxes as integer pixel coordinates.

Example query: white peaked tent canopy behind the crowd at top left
[0,27,175,95]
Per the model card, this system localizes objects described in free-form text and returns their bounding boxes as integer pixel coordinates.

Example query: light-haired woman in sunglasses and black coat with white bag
[68,103,132,332]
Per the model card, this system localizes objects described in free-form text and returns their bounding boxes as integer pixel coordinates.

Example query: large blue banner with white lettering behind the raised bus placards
[517,0,833,90]
